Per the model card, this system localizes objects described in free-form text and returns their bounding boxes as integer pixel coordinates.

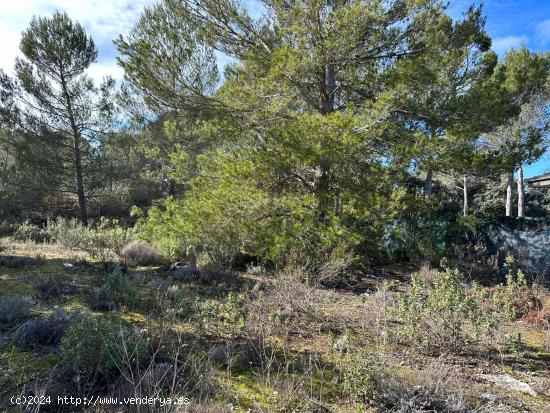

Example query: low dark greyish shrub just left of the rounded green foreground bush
[15,309,70,348]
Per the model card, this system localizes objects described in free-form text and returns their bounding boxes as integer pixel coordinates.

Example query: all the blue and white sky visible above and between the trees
[0,0,550,177]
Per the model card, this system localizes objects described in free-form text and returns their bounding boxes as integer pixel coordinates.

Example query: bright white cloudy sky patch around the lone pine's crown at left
[0,0,154,81]
